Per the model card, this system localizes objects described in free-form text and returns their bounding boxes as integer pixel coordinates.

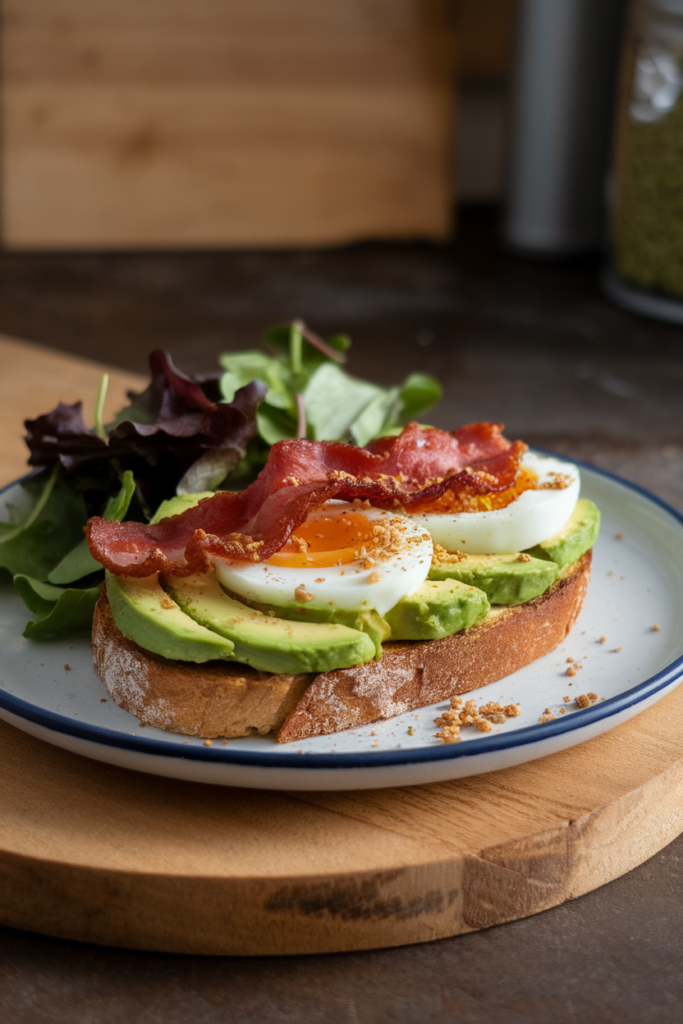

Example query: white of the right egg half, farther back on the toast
[410,452,581,555]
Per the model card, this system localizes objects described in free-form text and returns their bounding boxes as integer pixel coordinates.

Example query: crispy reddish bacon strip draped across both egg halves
[86,423,526,577]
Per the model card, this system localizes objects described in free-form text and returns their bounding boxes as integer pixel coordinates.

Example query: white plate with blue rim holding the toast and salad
[0,466,683,790]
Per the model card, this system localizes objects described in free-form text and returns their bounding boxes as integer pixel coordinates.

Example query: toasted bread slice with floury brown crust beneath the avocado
[92,551,592,743]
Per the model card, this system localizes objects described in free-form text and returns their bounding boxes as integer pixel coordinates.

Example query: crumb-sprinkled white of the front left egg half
[214,502,433,615]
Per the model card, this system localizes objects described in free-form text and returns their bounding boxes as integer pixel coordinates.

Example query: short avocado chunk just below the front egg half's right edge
[385,580,490,640]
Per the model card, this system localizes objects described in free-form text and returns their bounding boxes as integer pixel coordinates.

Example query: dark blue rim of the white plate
[0,450,683,769]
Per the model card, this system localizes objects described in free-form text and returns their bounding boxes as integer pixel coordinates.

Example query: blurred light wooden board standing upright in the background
[1,0,514,249]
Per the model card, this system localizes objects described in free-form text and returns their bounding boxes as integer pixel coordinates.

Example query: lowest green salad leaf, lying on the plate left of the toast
[14,573,101,640]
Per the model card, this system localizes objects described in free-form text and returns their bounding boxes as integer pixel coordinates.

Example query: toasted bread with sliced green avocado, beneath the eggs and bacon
[93,500,599,742]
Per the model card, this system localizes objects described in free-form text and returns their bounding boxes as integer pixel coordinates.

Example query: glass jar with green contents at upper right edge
[604,0,683,323]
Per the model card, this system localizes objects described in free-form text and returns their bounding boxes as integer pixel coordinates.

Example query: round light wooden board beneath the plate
[0,687,683,954]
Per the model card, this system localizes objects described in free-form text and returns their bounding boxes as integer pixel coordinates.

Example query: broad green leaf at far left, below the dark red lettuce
[0,473,87,580]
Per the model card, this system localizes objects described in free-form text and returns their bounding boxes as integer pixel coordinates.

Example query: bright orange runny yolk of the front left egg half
[267,510,373,568]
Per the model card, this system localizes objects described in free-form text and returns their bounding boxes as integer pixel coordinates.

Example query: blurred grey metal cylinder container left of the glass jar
[504,0,626,256]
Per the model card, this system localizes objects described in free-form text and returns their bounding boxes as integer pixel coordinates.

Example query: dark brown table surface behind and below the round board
[0,210,683,1024]
